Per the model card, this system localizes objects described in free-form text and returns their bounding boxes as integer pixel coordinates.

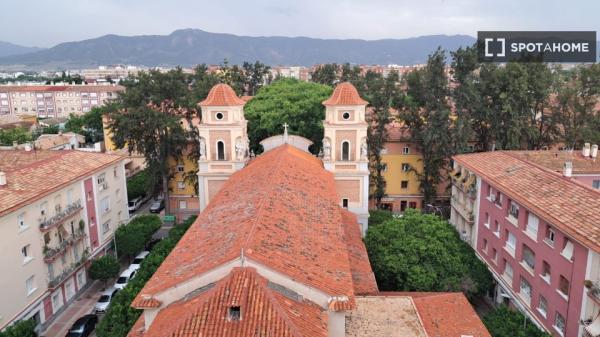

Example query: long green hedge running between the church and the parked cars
[96,216,196,337]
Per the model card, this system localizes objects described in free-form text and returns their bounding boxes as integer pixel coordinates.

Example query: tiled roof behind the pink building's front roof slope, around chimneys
[507,150,600,174]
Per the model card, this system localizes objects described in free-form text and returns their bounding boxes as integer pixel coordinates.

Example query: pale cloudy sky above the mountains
[0,0,600,47]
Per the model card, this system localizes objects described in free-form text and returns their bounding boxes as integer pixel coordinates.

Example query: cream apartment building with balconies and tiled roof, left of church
[0,147,129,330]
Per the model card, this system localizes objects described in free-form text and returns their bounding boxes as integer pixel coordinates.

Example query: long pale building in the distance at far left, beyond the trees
[0,84,124,118]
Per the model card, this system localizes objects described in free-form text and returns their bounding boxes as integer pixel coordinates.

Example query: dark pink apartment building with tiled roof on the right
[451,147,600,337]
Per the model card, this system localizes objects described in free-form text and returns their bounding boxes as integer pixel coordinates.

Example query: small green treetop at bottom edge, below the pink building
[483,306,551,337]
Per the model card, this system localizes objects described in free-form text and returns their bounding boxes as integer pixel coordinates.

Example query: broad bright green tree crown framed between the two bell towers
[244,78,332,154]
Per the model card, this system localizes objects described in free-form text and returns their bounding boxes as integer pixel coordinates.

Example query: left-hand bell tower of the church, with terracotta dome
[198,84,248,211]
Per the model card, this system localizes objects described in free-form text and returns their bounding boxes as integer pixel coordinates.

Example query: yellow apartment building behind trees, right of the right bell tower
[381,121,450,213]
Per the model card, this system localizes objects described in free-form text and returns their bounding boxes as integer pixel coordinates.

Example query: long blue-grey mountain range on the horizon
[0,29,475,69]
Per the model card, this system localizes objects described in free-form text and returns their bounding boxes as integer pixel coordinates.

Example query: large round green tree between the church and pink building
[365,210,492,297]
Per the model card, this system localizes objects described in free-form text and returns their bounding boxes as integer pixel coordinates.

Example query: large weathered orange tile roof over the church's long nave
[134,145,356,305]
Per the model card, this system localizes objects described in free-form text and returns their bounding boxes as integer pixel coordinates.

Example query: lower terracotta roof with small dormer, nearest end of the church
[141,267,327,337]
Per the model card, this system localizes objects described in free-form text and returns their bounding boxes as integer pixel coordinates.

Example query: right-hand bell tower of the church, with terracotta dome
[323,82,369,236]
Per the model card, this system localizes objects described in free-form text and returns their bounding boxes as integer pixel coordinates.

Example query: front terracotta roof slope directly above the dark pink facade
[454,151,600,252]
